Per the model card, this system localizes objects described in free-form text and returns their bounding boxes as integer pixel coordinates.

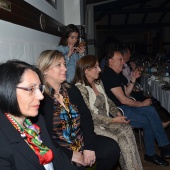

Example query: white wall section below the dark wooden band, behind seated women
[0,20,59,64]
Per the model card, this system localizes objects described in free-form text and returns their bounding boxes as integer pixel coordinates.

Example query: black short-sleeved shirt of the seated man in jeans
[101,67,128,106]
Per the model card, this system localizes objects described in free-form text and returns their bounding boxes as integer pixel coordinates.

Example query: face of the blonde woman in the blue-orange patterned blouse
[45,57,67,85]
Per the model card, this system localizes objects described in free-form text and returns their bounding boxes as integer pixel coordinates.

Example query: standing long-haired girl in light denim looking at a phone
[57,24,85,83]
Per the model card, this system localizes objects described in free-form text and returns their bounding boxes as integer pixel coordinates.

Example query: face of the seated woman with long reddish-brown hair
[85,61,101,82]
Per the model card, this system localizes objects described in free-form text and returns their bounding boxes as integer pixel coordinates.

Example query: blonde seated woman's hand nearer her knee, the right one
[83,150,96,167]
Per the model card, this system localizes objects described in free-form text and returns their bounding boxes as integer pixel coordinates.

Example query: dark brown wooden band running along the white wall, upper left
[0,0,64,36]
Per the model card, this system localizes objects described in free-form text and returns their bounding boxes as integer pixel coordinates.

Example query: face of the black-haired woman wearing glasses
[16,70,44,117]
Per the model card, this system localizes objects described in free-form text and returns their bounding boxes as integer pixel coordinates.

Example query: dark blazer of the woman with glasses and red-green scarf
[0,113,76,170]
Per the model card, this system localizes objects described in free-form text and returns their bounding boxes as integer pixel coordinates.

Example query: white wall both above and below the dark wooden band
[0,0,80,64]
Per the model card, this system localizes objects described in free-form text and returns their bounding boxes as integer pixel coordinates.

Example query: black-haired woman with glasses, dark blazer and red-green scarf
[0,60,76,170]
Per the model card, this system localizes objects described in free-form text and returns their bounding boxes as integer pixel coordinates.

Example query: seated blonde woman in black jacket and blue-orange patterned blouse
[38,50,120,170]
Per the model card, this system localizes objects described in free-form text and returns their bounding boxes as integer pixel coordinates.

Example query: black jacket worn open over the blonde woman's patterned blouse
[40,85,96,160]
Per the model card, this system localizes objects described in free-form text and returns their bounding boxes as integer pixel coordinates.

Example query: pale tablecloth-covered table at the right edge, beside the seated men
[141,75,170,113]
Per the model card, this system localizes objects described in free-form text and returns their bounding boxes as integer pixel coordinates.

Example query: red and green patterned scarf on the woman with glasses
[5,113,54,165]
